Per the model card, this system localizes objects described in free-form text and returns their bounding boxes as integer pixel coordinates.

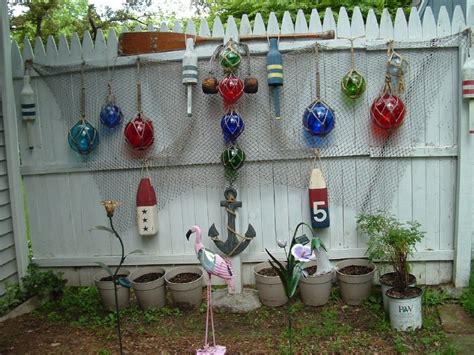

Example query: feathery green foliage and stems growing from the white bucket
[357,213,424,289]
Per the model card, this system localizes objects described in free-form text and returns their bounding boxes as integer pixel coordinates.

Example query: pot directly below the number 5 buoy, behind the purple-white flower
[300,261,334,306]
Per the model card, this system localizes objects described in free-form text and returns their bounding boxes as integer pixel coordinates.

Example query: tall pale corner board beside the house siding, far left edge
[0,1,28,277]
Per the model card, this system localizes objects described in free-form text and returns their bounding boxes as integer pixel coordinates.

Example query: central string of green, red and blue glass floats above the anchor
[202,38,258,184]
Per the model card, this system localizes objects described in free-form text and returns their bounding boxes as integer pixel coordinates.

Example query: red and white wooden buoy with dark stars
[137,177,158,236]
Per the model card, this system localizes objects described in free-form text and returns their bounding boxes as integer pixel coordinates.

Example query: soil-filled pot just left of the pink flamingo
[165,266,203,308]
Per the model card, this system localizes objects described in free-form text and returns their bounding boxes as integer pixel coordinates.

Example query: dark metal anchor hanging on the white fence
[208,187,256,256]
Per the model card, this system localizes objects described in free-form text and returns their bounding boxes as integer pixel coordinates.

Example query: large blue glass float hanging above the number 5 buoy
[303,100,334,136]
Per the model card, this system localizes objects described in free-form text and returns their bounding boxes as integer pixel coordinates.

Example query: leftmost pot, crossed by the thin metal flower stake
[94,268,130,311]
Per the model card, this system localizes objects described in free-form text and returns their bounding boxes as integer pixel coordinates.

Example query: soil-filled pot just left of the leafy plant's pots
[336,259,375,306]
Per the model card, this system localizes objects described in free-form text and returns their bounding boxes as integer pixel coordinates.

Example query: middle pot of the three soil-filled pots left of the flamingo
[129,266,166,310]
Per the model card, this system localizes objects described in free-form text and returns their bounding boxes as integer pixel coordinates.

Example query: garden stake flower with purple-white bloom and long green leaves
[265,222,325,354]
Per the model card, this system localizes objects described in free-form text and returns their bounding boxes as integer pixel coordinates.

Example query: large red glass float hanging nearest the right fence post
[370,93,406,131]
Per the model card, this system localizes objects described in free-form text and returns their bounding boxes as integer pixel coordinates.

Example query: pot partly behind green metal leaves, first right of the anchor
[253,261,288,307]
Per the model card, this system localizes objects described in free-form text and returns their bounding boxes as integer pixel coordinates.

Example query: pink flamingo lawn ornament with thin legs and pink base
[186,226,234,355]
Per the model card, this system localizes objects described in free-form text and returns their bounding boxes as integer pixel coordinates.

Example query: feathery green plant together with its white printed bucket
[357,214,424,330]
